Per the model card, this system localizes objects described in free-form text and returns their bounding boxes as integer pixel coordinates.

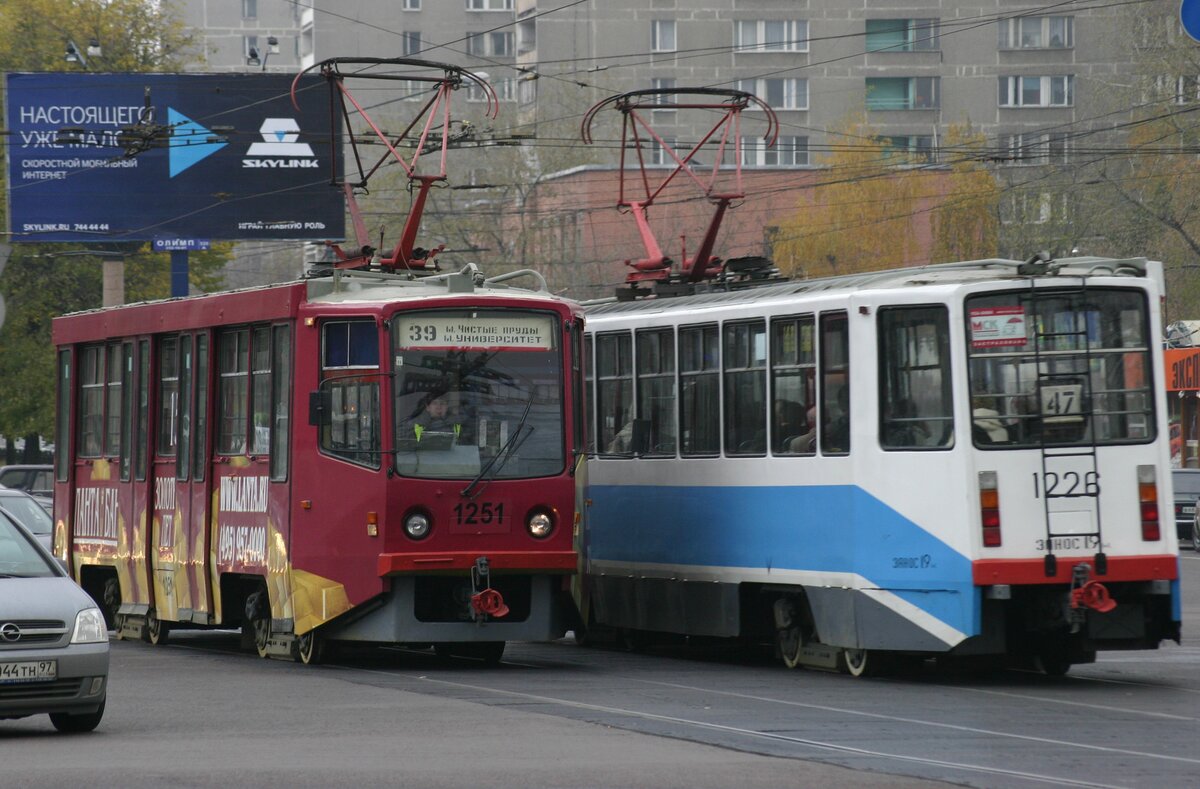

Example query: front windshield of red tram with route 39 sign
[392,309,565,480]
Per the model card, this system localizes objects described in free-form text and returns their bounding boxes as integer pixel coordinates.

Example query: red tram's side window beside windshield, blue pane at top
[320,320,382,469]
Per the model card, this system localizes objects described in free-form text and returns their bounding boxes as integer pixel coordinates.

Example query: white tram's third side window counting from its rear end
[770,315,817,454]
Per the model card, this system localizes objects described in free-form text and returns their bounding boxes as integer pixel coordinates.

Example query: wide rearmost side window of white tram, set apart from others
[878,306,954,450]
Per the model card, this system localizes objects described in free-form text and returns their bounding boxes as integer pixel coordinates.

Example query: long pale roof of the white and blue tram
[584,257,1148,315]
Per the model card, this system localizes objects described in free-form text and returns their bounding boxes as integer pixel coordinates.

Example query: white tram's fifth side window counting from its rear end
[679,326,721,456]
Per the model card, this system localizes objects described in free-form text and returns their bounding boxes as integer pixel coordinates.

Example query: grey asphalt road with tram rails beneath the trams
[0,550,1200,789]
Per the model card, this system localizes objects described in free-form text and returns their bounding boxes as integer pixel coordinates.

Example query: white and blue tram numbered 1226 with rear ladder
[582,258,1181,675]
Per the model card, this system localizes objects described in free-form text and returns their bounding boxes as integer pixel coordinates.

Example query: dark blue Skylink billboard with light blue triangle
[5,73,344,242]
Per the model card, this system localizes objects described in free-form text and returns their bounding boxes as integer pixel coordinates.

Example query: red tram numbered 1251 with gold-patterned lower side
[54,266,583,662]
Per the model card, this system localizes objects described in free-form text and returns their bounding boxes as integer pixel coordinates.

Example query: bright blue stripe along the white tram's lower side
[587,484,982,636]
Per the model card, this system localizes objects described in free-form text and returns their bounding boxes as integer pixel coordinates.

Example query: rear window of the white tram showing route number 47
[966,288,1154,448]
